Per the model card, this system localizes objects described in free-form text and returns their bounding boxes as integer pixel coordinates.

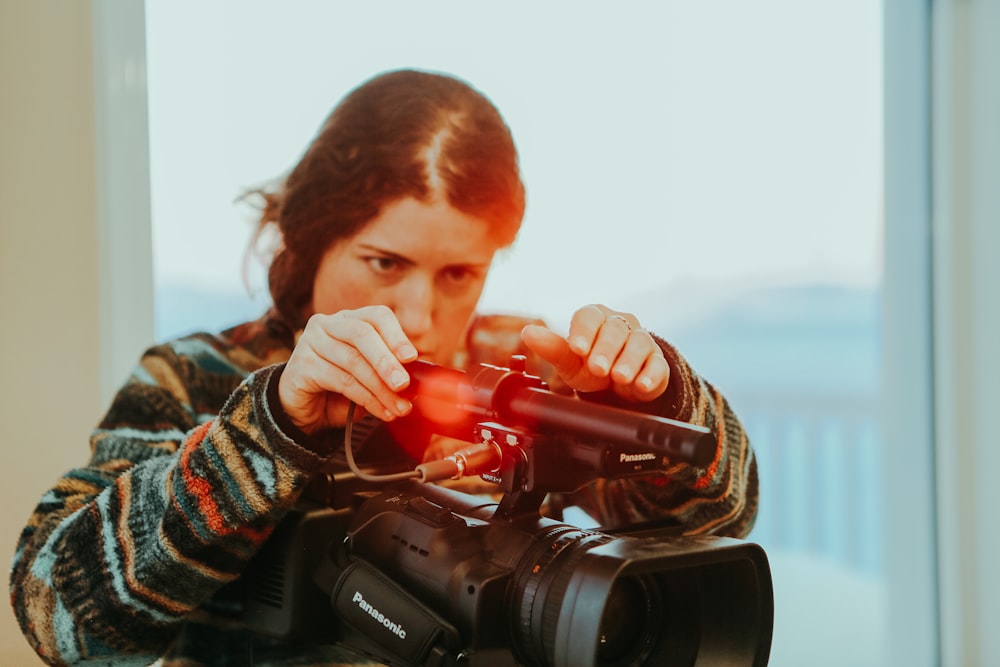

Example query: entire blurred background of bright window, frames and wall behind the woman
[0,0,1000,667]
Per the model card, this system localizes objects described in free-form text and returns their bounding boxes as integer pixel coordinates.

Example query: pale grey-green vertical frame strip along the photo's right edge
[925,0,1000,665]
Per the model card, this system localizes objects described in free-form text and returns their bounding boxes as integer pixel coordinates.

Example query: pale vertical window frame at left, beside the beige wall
[90,0,154,405]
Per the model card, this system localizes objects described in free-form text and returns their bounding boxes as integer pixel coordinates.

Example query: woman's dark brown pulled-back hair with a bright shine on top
[252,70,525,329]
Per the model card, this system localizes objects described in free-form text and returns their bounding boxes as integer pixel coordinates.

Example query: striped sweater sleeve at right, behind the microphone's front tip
[564,336,758,538]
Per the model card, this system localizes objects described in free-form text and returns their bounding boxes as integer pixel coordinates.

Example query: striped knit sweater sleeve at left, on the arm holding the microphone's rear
[10,348,323,665]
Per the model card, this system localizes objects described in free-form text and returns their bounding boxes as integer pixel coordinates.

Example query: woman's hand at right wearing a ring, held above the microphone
[521,304,670,401]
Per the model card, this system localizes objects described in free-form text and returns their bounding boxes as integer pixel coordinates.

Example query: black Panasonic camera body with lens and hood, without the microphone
[244,482,774,667]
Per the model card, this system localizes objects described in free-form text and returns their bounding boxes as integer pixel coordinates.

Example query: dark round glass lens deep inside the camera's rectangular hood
[597,577,662,667]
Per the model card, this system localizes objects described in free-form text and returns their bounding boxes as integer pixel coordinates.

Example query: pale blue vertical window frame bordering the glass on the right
[882,0,940,666]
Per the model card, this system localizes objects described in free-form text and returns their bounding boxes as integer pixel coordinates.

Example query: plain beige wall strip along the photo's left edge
[0,0,100,665]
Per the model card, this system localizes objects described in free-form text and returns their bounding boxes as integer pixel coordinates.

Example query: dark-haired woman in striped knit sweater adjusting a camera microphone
[11,71,757,665]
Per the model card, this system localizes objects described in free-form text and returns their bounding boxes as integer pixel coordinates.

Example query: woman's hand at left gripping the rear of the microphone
[278,306,417,433]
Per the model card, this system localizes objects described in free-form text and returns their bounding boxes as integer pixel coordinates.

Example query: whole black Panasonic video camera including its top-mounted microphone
[241,357,773,667]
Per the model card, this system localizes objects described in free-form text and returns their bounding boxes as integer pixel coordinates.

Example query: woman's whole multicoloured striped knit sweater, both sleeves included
[10,314,757,667]
